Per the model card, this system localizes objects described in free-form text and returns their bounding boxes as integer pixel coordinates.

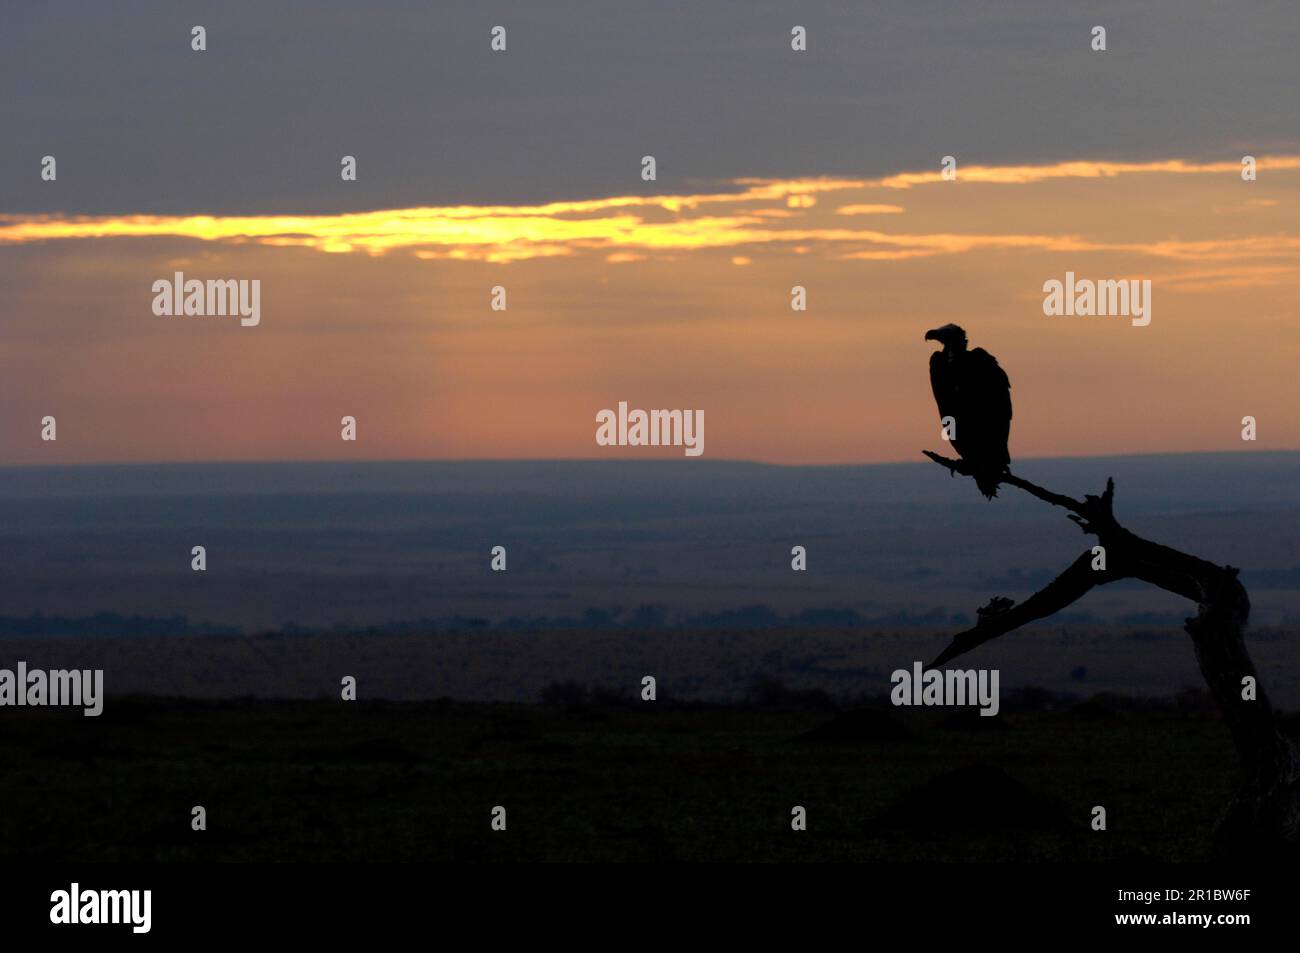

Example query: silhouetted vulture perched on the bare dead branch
[926,324,1011,499]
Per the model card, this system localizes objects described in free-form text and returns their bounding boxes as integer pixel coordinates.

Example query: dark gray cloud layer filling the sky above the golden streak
[0,0,1300,213]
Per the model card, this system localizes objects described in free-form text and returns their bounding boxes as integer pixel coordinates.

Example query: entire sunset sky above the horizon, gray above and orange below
[0,3,1300,465]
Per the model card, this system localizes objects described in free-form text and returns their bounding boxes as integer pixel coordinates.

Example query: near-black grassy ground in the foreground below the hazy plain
[0,685,1296,863]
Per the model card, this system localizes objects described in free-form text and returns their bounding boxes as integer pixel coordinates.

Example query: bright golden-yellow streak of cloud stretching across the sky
[0,156,1300,264]
